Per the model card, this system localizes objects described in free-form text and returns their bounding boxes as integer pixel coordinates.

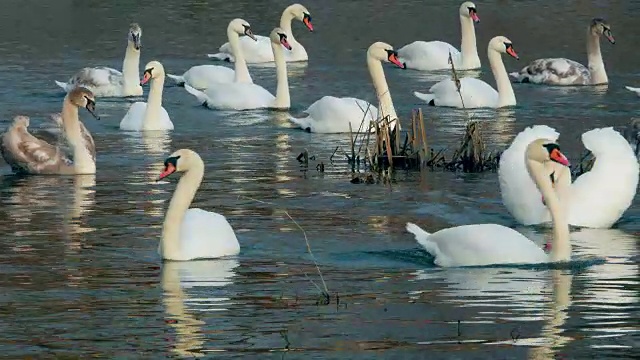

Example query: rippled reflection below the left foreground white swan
[162,258,239,357]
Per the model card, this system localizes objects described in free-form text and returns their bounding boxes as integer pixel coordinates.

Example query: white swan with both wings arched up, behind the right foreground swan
[498,125,640,228]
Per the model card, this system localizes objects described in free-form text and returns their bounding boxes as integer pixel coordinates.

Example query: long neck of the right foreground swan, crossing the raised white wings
[526,159,571,262]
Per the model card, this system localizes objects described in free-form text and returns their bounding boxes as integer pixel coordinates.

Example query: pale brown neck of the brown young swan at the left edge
[62,97,96,174]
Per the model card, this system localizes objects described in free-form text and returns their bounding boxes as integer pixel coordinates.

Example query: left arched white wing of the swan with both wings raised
[498,125,560,225]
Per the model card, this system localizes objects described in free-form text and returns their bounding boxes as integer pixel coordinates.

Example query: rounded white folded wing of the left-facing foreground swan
[180,208,240,259]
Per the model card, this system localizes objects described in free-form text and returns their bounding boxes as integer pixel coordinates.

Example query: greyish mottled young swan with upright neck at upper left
[56,23,142,97]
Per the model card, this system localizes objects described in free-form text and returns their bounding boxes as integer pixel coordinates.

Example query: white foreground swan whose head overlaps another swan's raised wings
[407,139,571,267]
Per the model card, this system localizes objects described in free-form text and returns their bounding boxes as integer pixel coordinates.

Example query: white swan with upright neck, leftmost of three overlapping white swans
[167,19,258,90]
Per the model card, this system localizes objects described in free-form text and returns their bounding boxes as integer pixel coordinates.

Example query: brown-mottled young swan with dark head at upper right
[509,18,615,85]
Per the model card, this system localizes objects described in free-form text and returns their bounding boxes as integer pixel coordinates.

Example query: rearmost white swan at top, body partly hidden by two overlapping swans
[207,4,313,64]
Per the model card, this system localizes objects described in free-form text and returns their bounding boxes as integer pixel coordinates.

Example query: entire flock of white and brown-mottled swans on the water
[0,1,640,267]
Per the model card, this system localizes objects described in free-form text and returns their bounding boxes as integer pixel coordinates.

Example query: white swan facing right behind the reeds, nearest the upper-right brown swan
[413,36,519,109]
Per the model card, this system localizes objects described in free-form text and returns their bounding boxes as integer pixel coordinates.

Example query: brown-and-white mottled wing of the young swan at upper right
[509,58,591,85]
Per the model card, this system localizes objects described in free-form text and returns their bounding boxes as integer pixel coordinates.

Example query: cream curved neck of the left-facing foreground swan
[160,159,204,260]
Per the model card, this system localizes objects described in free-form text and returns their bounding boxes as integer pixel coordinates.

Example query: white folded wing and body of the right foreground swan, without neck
[407,224,549,267]
